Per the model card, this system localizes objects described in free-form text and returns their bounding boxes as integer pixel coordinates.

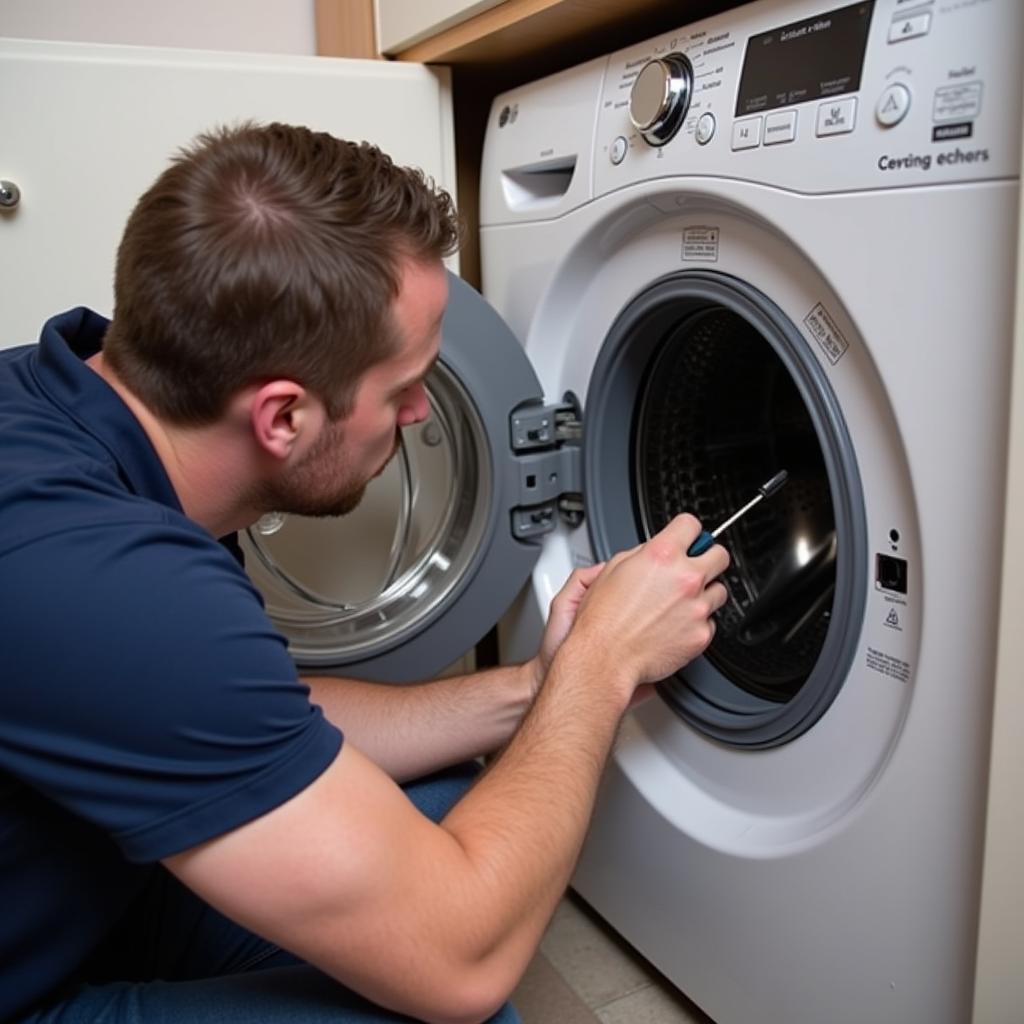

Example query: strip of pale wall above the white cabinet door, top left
[0,0,316,54]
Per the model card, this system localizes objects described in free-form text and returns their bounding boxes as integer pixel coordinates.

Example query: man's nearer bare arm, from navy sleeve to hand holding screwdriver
[167,516,728,1022]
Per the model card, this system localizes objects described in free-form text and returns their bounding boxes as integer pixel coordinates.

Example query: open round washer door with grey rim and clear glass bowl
[241,273,542,682]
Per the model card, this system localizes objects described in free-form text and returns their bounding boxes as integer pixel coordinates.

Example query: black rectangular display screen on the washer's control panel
[736,0,874,116]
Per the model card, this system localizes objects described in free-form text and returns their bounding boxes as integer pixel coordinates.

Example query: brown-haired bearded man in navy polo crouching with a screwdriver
[0,125,728,1024]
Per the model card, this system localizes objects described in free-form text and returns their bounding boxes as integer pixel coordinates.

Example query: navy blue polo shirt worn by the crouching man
[0,309,341,1020]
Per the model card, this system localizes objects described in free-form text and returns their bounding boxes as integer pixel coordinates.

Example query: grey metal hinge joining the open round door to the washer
[509,392,583,539]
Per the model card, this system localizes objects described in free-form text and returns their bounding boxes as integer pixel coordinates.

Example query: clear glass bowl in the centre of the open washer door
[242,364,492,668]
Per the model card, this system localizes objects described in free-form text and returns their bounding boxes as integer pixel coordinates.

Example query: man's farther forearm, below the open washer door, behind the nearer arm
[304,664,538,782]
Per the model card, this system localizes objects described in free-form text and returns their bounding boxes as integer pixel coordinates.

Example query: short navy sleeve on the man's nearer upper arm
[0,516,342,861]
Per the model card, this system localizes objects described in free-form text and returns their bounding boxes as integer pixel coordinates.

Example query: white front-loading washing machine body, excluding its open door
[481,0,1024,1024]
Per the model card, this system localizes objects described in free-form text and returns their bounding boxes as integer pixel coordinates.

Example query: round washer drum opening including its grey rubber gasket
[585,272,864,746]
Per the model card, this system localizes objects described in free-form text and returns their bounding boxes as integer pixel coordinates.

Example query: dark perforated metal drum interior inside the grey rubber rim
[635,307,837,701]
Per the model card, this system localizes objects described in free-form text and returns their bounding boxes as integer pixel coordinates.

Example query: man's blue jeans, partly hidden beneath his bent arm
[19,764,519,1024]
